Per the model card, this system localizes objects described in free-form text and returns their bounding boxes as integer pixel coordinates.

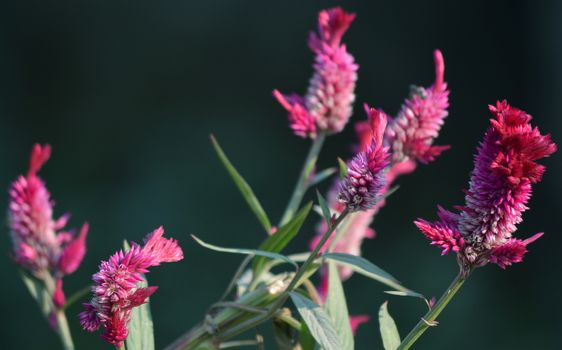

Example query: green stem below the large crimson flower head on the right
[397,271,470,350]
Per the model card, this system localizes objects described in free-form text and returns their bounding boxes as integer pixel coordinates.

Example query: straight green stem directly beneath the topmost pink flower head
[279,132,326,227]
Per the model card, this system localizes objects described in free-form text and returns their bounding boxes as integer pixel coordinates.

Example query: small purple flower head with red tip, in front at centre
[338,106,389,211]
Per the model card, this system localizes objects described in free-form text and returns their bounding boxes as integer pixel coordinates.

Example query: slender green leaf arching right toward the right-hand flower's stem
[323,253,406,290]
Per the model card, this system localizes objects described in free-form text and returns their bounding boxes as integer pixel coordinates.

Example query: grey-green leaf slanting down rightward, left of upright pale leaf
[289,292,342,350]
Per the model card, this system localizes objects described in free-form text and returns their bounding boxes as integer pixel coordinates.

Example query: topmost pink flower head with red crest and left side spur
[274,7,358,138]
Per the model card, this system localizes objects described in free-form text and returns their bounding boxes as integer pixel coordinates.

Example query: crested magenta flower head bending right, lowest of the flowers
[80,227,183,347]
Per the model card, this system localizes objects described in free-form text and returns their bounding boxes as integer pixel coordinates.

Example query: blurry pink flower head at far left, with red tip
[8,144,86,276]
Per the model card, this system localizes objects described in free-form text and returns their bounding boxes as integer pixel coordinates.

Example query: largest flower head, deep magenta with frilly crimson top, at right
[415,101,556,271]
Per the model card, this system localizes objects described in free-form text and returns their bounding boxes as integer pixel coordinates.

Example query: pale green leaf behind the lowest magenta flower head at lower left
[123,241,154,350]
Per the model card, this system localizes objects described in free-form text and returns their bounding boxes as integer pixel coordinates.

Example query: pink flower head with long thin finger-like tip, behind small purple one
[385,50,449,164]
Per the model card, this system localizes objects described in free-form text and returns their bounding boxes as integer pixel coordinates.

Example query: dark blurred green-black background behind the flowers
[0,0,562,350]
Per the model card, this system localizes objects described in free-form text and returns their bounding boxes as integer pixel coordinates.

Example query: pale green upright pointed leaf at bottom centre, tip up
[324,262,355,350]
